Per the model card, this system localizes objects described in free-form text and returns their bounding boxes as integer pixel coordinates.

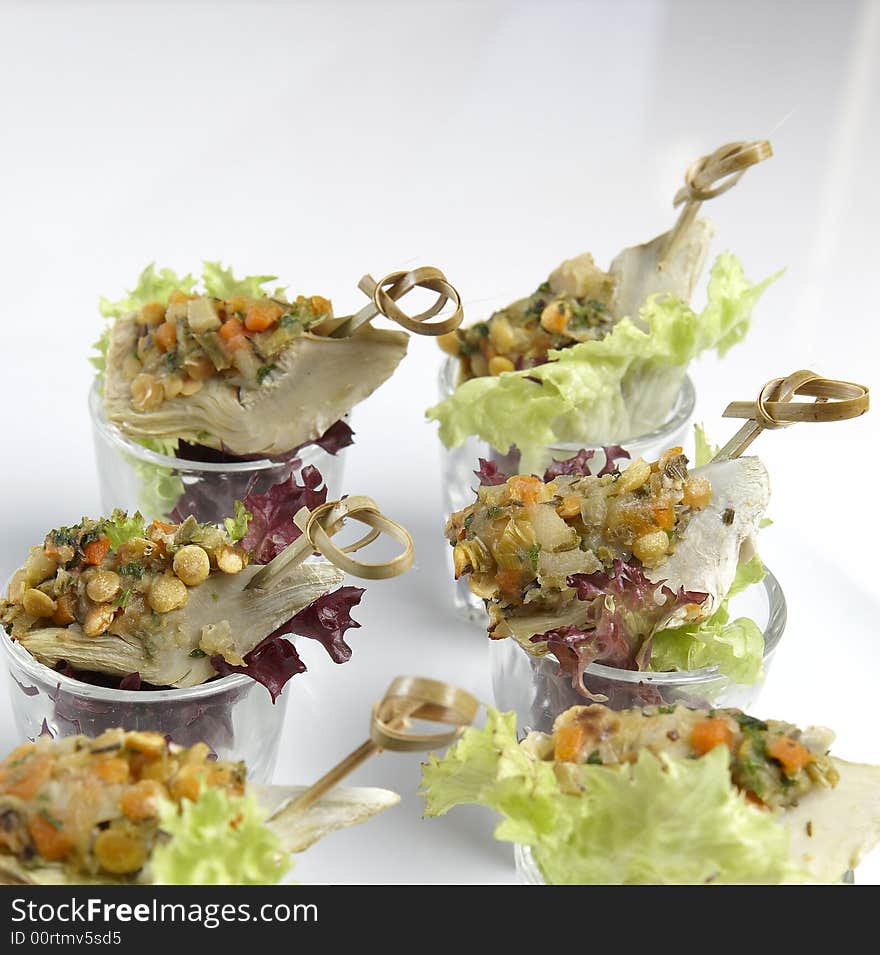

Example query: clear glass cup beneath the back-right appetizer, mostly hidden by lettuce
[440,358,696,624]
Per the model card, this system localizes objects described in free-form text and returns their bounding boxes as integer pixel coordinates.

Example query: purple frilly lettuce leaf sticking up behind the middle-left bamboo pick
[241,465,327,564]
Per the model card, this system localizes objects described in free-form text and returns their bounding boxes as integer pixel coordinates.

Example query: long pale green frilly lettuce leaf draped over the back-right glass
[427,253,776,465]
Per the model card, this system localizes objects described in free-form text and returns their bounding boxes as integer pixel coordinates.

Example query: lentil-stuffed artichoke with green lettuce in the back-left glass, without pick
[96,262,408,456]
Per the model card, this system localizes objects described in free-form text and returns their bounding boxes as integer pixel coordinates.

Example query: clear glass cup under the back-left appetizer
[89,383,348,523]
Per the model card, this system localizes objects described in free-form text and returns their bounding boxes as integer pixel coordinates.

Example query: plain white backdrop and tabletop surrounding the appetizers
[0,0,880,882]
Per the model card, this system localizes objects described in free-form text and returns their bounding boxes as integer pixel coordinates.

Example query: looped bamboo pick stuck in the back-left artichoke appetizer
[330,265,464,338]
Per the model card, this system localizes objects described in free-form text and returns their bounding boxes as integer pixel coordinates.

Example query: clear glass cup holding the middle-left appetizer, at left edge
[0,627,288,783]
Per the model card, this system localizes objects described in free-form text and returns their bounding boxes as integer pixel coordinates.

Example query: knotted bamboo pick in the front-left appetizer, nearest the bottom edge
[288,676,480,812]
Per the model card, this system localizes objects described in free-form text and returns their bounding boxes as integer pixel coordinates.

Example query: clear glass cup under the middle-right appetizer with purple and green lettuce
[489,571,786,735]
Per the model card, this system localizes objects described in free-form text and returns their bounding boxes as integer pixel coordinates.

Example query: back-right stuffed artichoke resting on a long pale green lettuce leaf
[427,143,773,472]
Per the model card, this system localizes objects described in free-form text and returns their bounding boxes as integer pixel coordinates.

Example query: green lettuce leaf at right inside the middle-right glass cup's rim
[649,554,766,685]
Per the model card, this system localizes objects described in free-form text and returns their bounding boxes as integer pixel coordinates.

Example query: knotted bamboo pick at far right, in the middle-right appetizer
[713,369,870,461]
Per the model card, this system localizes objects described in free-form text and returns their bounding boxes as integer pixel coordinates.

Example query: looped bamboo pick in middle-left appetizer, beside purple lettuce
[245,495,415,590]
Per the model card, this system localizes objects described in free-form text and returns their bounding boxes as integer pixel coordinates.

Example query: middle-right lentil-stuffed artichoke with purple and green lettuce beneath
[446,447,769,691]
